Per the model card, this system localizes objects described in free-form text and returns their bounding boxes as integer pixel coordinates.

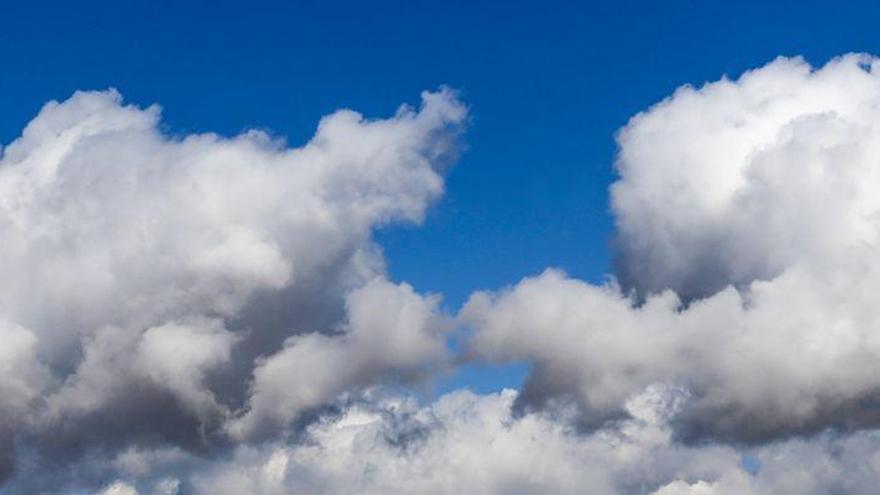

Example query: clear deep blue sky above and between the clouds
[0,0,880,396]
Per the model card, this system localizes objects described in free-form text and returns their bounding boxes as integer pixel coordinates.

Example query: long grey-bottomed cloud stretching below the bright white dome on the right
[464,264,880,441]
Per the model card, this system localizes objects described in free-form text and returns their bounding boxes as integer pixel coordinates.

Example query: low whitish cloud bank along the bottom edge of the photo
[65,387,880,495]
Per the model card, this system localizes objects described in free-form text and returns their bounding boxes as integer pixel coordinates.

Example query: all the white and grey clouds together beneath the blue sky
[0,55,880,495]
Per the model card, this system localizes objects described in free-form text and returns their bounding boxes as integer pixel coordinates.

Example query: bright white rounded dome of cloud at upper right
[611,55,880,299]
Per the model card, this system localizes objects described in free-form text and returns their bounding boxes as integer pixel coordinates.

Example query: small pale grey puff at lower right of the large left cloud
[229,279,446,438]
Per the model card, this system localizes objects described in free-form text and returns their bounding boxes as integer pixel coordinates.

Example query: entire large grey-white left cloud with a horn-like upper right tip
[0,90,466,486]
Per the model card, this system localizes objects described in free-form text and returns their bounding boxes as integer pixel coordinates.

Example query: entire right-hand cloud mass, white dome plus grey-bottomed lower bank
[463,55,880,446]
